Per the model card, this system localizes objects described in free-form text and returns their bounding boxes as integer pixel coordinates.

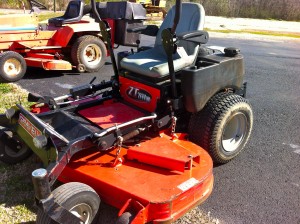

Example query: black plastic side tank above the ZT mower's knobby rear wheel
[181,54,244,113]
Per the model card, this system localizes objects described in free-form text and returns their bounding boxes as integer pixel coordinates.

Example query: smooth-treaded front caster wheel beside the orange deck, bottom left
[36,182,100,224]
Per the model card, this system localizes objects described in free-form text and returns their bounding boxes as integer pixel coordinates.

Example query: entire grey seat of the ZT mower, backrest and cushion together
[120,3,205,78]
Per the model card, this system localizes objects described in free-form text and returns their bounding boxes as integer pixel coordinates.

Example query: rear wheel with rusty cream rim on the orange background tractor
[71,35,107,72]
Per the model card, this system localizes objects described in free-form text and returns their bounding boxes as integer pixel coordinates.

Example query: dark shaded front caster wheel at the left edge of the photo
[0,133,32,164]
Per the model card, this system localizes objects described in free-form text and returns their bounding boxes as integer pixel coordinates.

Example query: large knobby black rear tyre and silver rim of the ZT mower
[189,93,253,164]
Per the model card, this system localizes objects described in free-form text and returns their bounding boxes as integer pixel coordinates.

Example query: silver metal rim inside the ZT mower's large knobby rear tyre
[222,113,247,152]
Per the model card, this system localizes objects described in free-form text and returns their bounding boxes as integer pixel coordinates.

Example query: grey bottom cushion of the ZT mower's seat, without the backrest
[121,46,194,78]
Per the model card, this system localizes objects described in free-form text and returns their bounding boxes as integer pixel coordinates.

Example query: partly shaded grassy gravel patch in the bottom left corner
[0,157,37,224]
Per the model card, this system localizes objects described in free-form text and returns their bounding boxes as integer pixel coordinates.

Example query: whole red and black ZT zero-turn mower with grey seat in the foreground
[0,0,253,224]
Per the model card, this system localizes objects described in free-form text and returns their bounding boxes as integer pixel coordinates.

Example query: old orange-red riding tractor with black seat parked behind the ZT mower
[0,0,146,82]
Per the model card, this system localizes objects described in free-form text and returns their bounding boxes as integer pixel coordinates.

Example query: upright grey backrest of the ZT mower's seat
[155,2,205,55]
